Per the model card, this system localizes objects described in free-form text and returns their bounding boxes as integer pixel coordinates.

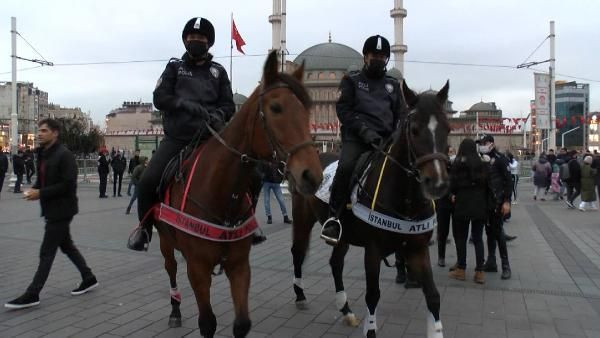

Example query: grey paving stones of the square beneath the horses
[0,184,600,338]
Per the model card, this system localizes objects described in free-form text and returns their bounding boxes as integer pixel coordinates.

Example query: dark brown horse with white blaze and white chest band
[292,83,450,338]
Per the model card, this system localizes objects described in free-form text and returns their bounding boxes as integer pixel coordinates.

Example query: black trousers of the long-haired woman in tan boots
[452,217,485,271]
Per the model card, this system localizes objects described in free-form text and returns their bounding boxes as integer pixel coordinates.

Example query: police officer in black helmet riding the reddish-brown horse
[127,17,235,251]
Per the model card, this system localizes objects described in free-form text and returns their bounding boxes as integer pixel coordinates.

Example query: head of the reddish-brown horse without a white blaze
[256,52,323,195]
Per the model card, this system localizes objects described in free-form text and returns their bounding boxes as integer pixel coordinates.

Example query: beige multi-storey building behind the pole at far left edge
[0,82,48,149]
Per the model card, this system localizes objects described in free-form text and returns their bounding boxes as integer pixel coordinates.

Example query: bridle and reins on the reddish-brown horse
[206,82,314,168]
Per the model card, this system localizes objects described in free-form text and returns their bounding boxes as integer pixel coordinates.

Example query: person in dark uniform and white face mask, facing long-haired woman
[479,135,512,279]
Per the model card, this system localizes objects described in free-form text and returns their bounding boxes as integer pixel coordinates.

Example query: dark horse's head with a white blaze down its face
[401,81,450,199]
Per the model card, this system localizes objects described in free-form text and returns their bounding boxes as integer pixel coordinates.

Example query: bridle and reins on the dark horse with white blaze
[376,111,448,183]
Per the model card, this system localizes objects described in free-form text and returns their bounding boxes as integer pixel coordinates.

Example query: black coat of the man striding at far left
[33,143,79,220]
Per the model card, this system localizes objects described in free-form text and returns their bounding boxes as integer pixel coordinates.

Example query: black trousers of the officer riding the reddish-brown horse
[136,137,187,226]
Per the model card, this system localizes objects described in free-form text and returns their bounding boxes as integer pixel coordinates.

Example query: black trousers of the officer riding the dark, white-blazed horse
[329,141,372,216]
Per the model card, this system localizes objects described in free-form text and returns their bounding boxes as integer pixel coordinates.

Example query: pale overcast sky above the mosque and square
[0,0,600,122]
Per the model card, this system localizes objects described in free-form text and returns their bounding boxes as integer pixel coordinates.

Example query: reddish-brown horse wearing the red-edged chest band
[156,52,322,337]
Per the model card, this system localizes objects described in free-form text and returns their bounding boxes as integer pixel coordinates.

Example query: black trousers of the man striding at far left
[27,218,93,295]
